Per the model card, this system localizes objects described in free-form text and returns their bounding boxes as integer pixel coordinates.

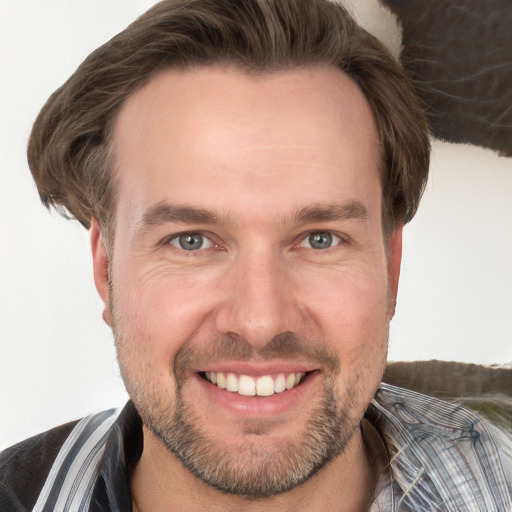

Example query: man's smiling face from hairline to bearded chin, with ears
[93,67,400,497]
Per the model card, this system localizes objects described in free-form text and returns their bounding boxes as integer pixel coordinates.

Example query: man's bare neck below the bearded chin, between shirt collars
[131,422,376,512]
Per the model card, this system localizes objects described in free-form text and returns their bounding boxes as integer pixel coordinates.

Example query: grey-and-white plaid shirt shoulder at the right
[368,384,512,511]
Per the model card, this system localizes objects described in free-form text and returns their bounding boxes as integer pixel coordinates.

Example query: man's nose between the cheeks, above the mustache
[216,250,303,348]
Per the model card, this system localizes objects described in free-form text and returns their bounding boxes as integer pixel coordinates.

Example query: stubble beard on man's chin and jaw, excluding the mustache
[148,372,358,500]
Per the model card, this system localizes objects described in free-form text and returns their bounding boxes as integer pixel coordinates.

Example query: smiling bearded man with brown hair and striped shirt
[0,0,512,512]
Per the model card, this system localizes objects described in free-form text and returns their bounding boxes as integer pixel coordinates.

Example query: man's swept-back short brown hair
[28,0,430,243]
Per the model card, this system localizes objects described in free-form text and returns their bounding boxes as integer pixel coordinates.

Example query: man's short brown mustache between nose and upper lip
[173,332,340,382]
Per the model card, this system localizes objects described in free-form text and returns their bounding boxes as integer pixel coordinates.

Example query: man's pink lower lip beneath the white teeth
[195,372,319,418]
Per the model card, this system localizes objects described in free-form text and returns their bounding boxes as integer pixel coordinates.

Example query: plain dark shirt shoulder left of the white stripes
[0,421,78,511]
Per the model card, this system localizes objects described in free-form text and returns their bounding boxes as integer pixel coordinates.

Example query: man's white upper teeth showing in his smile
[204,372,305,396]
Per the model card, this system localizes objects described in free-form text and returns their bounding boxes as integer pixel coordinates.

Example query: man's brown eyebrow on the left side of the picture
[141,202,219,229]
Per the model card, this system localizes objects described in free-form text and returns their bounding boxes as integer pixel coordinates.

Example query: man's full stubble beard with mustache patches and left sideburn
[114,324,370,500]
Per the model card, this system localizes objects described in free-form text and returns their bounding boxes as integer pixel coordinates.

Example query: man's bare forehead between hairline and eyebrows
[114,67,380,229]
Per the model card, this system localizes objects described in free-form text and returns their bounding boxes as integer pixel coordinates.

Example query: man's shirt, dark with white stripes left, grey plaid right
[0,384,512,512]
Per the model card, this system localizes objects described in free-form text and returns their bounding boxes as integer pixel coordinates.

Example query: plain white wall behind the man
[0,0,512,449]
